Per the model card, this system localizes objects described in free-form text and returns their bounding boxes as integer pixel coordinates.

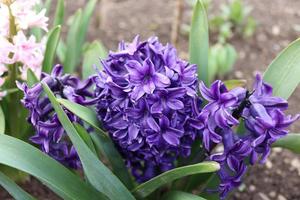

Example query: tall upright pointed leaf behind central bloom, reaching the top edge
[189,0,209,84]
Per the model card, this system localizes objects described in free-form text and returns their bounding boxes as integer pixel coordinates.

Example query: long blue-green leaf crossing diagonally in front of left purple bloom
[42,83,134,200]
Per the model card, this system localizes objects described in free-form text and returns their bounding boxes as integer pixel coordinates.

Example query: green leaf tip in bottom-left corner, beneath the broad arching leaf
[0,172,35,200]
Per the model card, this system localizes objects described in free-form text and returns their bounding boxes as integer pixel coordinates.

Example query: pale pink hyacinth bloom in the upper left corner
[0,0,48,97]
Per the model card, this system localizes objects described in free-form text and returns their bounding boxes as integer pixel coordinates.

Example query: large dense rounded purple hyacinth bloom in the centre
[94,36,201,182]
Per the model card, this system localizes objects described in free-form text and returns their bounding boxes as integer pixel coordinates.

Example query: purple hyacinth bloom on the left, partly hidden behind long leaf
[18,65,94,169]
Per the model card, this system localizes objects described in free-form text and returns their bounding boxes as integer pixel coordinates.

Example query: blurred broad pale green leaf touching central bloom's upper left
[82,41,107,79]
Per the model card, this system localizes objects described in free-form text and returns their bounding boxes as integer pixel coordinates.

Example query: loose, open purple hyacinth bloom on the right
[194,75,299,198]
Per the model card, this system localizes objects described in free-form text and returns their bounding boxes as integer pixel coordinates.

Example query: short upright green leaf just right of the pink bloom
[43,25,61,73]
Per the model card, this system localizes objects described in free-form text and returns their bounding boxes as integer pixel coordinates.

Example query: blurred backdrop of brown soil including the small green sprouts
[0,0,300,200]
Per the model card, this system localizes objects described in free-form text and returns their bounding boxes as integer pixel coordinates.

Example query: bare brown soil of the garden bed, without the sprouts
[0,0,300,200]
